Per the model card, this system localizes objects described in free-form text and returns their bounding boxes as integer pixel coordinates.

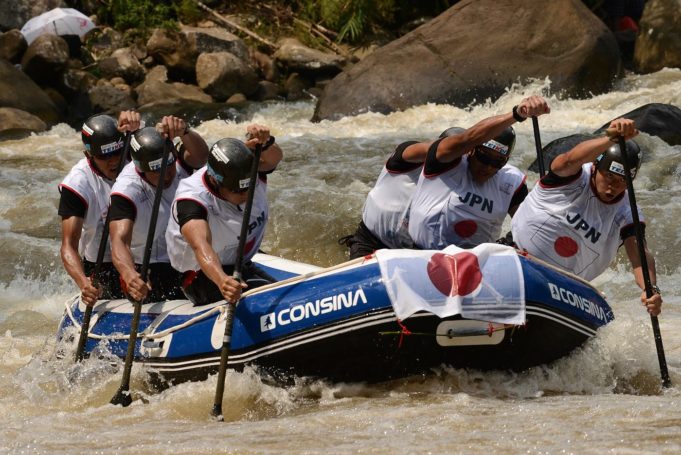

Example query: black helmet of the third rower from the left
[207,138,253,193]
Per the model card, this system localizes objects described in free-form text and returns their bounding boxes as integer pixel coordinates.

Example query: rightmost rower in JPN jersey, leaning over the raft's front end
[512,118,662,315]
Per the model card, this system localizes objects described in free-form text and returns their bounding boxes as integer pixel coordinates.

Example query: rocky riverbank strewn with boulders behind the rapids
[0,0,681,138]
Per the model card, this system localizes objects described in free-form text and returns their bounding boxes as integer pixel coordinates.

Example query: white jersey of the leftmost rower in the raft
[59,158,113,262]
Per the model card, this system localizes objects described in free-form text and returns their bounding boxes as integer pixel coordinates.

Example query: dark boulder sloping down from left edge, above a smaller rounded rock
[0,59,60,125]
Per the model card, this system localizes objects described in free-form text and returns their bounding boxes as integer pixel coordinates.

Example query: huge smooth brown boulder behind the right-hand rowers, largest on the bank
[313,0,620,120]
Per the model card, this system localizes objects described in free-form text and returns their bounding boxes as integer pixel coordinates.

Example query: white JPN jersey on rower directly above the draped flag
[409,155,525,250]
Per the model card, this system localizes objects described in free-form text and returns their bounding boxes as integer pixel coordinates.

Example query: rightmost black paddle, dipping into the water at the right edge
[618,136,672,388]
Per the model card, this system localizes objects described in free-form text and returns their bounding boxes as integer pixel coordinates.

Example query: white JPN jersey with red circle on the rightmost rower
[512,163,643,280]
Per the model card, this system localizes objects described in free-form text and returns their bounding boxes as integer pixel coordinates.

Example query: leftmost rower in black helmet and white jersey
[58,111,140,305]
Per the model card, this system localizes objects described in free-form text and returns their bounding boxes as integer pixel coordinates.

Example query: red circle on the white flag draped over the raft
[427,252,482,296]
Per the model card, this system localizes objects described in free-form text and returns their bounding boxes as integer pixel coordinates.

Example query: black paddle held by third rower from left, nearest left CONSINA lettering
[211,144,262,421]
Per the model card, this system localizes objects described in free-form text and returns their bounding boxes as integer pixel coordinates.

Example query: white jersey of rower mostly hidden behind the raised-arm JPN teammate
[362,153,423,248]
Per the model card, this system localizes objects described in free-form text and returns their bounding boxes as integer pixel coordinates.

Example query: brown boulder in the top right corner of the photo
[634,0,681,73]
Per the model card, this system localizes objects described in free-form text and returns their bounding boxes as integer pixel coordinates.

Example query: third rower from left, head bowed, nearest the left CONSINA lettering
[166,124,283,305]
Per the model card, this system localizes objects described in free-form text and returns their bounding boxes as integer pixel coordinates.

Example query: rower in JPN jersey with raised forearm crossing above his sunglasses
[409,96,549,249]
